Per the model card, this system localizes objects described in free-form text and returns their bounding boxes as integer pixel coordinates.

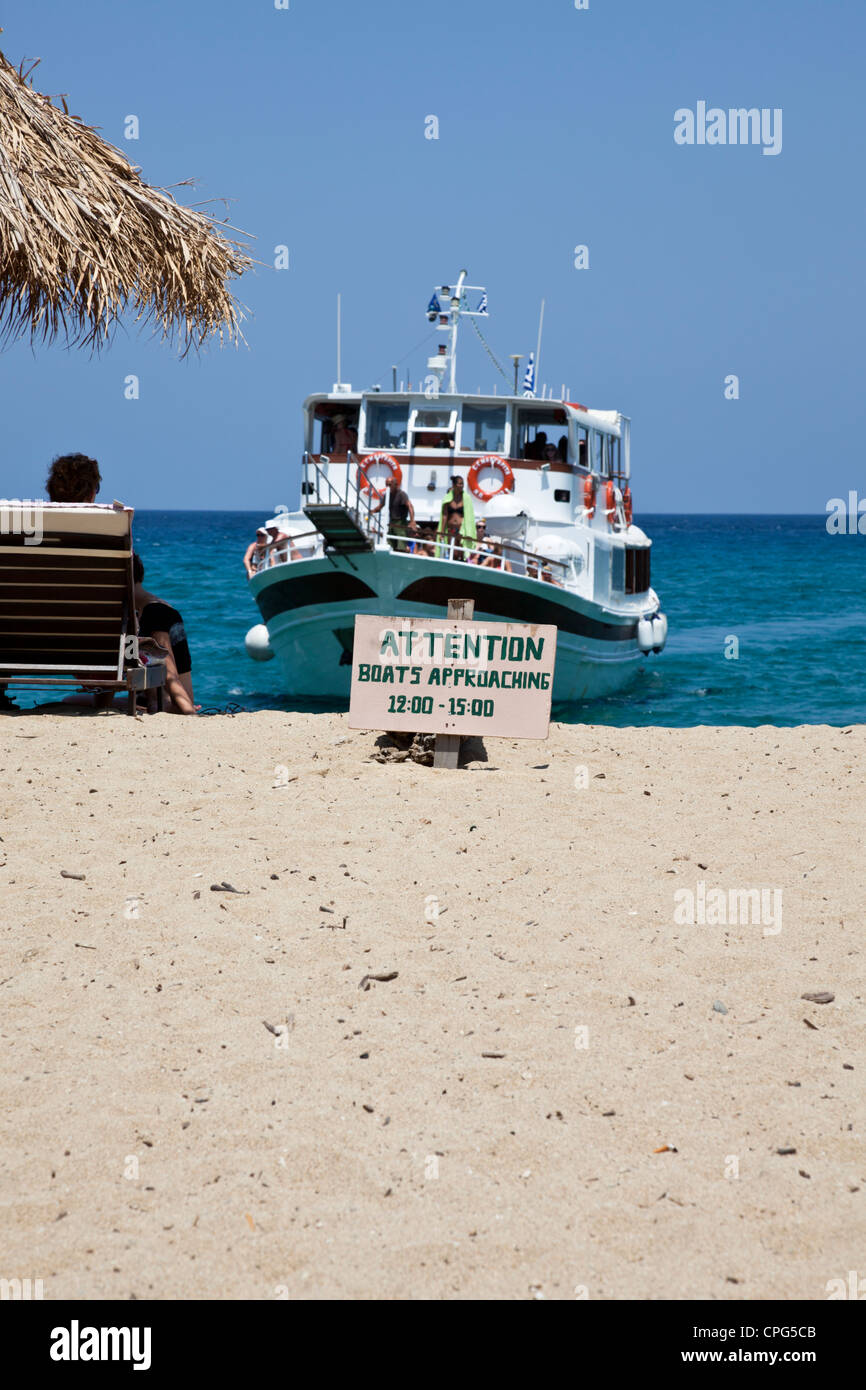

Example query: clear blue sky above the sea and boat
[0,0,866,512]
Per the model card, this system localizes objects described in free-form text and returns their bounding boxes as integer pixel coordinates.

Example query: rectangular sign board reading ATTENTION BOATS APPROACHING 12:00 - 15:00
[349,614,556,738]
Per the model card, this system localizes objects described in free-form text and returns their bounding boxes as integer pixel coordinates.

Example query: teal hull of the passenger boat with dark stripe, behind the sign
[250,549,657,702]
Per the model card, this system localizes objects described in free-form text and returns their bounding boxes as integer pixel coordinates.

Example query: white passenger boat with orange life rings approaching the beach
[246,272,667,701]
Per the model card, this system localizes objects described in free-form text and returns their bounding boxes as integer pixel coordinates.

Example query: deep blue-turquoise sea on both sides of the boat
[123,512,866,728]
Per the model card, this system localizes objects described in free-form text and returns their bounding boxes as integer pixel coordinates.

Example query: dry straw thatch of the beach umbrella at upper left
[0,53,252,352]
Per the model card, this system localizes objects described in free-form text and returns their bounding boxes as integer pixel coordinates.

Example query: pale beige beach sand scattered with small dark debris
[0,713,866,1300]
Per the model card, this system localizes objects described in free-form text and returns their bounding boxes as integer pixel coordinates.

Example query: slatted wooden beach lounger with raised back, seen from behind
[0,500,165,714]
